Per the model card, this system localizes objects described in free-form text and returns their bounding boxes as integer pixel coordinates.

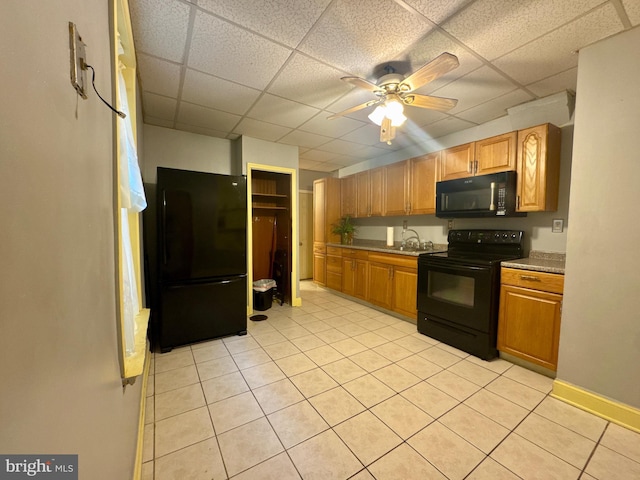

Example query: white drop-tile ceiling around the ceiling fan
[129,0,640,172]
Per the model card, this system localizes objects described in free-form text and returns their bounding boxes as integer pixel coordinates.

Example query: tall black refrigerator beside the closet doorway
[155,167,247,352]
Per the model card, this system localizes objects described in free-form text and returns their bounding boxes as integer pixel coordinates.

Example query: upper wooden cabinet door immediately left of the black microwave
[409,152,440,215]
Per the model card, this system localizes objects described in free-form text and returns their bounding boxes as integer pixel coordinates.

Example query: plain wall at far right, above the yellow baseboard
[558,28,640,408]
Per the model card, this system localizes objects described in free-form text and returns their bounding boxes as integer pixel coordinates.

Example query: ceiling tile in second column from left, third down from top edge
[182,68,260,115]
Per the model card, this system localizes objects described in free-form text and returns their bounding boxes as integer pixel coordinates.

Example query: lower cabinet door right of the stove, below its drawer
[498,285,562,371]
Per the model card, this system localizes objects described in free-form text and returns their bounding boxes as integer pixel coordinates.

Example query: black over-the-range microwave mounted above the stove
[436,172,527,218]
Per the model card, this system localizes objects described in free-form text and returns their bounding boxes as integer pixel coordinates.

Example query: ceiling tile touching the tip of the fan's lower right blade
[434,67,517,115]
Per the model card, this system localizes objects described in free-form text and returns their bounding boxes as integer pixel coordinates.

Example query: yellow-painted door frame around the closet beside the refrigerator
[247,163,302,315]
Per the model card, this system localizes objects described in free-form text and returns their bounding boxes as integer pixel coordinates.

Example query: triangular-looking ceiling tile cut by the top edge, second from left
[198,0,331,47]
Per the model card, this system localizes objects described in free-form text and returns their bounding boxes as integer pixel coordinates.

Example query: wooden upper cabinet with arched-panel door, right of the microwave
[517,123,561,212]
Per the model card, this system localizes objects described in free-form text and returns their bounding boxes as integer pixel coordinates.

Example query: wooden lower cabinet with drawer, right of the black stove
[498,268,564,371]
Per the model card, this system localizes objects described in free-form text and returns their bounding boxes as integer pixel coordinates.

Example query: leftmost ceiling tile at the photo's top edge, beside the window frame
[129,0,193,62]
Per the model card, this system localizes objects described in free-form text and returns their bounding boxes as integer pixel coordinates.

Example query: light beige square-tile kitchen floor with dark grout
[143,282,640,480]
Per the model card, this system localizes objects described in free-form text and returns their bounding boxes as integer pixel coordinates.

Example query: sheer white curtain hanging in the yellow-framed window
[118,38,147,356]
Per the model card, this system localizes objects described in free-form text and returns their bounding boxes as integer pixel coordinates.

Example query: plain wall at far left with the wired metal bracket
[0,0,141,480]
